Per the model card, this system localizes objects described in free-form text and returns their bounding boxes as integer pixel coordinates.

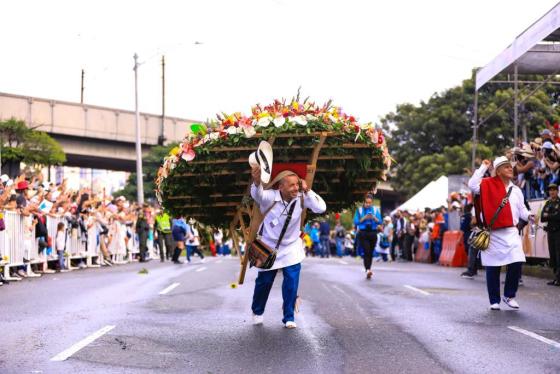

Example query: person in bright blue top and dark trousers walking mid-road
[354,194,382,279]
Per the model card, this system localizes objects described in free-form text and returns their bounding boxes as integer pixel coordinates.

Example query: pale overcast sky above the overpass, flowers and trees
[0,0,556,121]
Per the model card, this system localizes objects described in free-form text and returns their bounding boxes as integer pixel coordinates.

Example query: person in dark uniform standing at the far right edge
[541,183,560,286]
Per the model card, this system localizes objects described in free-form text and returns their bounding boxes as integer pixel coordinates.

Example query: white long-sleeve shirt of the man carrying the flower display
[251,184,327,270]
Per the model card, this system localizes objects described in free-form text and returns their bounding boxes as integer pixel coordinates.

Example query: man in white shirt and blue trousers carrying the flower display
[251,167,327,329]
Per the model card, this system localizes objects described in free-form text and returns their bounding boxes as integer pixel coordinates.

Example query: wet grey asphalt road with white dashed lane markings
[0,258,560,374]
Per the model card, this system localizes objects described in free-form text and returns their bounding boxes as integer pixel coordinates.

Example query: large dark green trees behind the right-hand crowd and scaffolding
[382,72,560,196]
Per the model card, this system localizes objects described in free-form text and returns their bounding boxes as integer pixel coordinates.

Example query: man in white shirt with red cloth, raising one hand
[469,156,529,310]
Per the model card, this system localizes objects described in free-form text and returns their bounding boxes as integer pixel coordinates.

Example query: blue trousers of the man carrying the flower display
[251,264,301,323]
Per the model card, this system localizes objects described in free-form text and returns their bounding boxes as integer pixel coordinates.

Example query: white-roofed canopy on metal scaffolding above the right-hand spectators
[472,3,560,168]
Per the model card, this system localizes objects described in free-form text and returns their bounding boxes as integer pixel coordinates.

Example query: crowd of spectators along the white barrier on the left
[0,174,238,285]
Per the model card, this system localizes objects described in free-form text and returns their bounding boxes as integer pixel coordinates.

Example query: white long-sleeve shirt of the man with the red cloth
[469,164,529,266]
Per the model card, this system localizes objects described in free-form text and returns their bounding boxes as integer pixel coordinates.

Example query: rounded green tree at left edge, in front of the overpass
[0,118,66,165]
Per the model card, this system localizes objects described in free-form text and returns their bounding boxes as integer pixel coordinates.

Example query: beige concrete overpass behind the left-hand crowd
[0,92,197,172]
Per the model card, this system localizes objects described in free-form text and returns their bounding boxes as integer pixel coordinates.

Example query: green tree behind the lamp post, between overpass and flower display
[113,143,177,201]
